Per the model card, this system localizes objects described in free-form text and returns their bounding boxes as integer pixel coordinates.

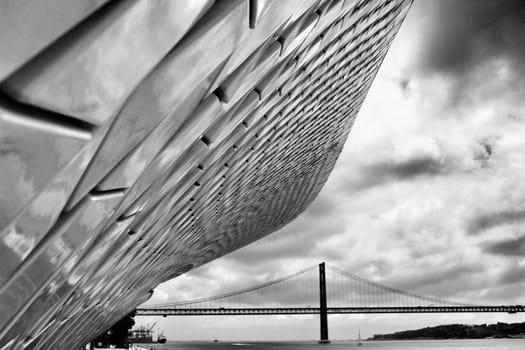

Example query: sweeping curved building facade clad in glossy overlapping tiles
[0,0,411,350]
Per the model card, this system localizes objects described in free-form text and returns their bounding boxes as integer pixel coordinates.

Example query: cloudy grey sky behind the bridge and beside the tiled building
[137,0,525,340]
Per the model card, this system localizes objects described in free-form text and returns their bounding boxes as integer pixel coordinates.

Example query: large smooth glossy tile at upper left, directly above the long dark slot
[3,0,214,124]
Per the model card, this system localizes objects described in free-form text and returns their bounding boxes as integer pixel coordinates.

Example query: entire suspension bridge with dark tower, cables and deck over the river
[136,263,525,342]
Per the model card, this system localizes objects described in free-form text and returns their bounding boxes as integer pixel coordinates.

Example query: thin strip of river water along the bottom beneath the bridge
[135,339,525,350]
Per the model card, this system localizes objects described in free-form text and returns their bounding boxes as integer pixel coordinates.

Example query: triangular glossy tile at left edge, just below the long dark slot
[0,99,92,227]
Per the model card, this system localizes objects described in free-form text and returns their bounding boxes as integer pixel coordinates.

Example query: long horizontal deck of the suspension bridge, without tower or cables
[137,305,525,316]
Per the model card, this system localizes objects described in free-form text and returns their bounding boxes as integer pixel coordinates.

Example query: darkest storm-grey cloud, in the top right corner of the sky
[414,0,525,78]
